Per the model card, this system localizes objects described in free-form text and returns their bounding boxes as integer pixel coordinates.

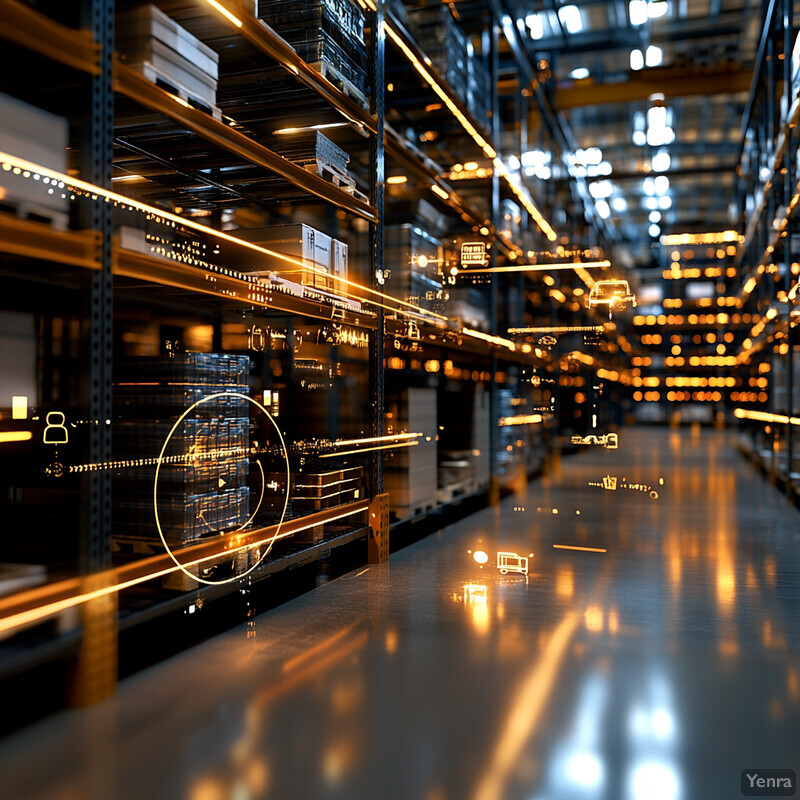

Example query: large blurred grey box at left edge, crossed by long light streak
[0,94,69,230]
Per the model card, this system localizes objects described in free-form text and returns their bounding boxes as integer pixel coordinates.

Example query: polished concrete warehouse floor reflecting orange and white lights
[0,429,800,800]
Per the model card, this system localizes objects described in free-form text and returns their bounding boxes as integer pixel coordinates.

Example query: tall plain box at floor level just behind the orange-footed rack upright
[384,388,437,519]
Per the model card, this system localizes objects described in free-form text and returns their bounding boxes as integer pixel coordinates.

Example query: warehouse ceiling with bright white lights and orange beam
[505,0,761,266]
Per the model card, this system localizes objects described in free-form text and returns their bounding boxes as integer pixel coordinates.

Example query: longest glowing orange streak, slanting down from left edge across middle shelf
[0,151,447,322]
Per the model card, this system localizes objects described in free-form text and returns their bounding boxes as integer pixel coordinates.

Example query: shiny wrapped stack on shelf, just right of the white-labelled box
[384,223,445,313]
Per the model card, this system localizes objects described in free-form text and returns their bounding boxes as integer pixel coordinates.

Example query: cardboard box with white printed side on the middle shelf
[235,223,348,290]
